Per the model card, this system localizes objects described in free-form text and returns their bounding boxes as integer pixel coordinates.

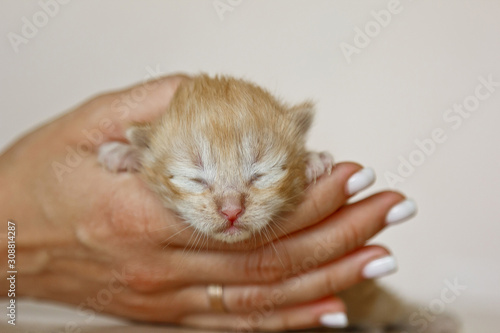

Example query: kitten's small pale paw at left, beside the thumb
[97,142,140,172]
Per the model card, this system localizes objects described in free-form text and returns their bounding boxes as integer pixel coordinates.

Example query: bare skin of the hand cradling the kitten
[0,75,410,330]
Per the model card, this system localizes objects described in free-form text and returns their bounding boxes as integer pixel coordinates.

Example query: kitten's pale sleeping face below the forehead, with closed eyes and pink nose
[156,130,305,242]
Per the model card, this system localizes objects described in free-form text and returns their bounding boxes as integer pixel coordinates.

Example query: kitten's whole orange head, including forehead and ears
[133,74,312,243]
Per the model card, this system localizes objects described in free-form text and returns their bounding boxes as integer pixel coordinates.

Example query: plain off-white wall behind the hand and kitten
[0,0,500,333]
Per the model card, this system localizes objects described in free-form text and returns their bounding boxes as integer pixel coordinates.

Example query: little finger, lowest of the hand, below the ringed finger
[180,297,347,332]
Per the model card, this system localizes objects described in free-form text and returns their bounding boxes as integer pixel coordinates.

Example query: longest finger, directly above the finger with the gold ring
[174,192,412,284]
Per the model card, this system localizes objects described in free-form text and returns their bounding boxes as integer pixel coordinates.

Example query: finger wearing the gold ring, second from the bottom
[95,246,394,321]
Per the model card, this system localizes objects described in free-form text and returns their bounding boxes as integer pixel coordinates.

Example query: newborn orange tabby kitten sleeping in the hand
[95,75,455,333]
